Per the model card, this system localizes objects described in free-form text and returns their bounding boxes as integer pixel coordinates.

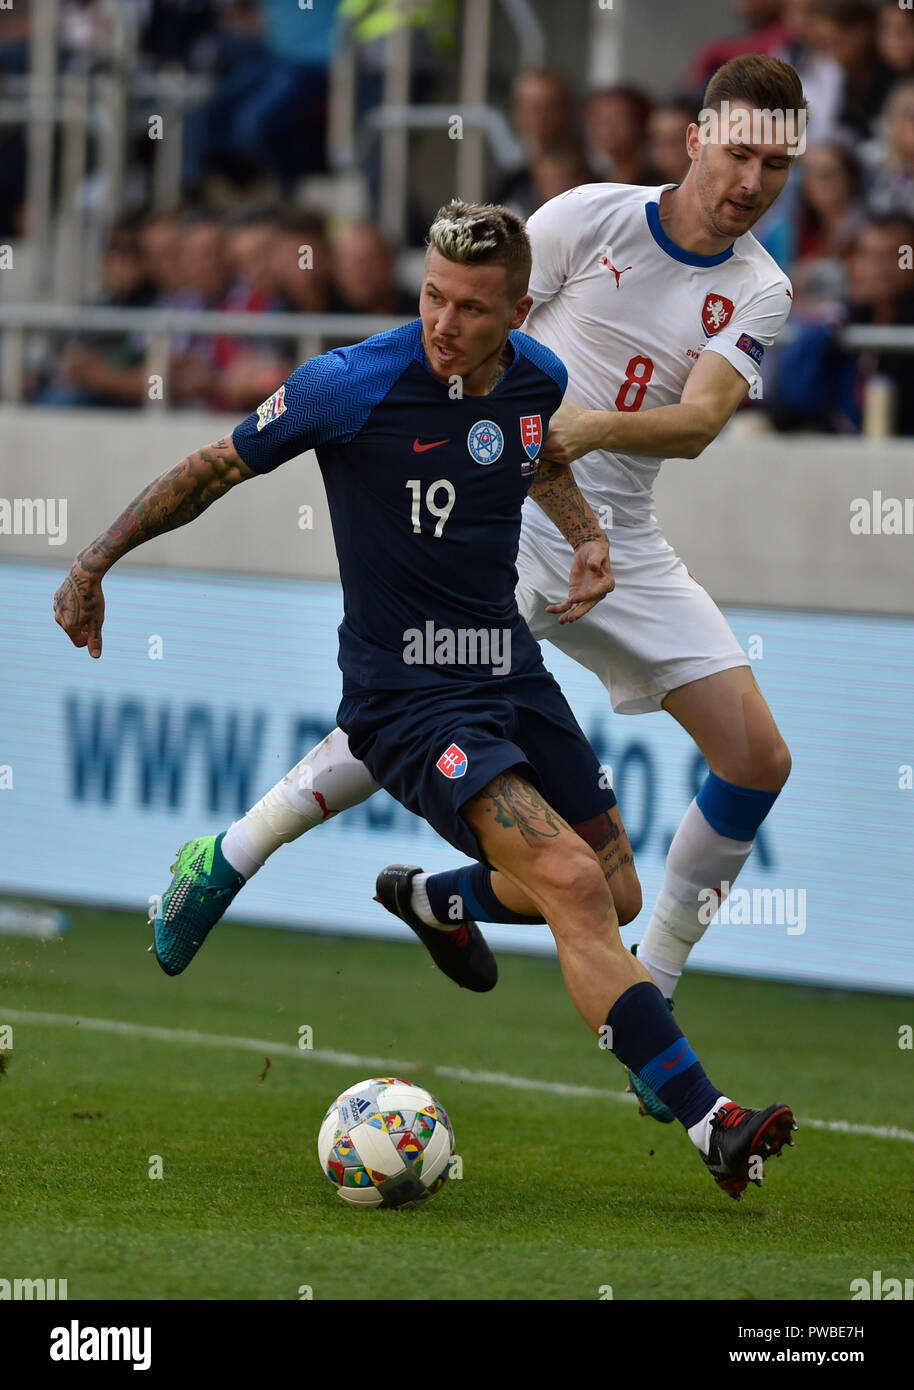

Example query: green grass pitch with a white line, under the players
[0,909,914,1300]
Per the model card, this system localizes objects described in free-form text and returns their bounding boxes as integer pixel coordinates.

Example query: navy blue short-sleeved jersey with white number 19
[233,320,567,692]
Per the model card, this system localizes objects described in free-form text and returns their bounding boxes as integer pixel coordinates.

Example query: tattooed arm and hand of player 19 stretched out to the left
[54,435,254,656]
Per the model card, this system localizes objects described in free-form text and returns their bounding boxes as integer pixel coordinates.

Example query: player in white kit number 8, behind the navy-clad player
[140,54,804,1119]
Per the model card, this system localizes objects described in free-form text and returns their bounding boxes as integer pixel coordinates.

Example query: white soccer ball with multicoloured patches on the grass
[317,1076,454,1207]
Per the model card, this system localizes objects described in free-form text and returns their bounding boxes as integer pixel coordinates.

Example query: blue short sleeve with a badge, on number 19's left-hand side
[232,350,369,473]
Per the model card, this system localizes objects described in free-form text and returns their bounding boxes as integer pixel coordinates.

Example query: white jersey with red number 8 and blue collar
[524,183,792,528]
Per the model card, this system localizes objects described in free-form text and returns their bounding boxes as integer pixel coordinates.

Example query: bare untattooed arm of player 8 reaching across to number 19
[543,352,749,463]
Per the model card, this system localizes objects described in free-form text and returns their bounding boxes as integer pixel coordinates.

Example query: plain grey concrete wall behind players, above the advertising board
[0,407,914,614]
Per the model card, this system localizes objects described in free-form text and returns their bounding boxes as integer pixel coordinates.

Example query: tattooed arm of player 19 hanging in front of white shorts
[529,461,615,623]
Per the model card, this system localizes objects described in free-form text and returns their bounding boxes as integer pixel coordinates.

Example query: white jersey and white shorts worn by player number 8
[517,173,790,714]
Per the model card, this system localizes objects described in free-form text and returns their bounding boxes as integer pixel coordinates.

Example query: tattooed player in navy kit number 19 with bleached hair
[57,203,795,1197]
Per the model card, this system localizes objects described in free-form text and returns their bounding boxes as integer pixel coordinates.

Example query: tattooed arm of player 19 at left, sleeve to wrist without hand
[78,438,251,574]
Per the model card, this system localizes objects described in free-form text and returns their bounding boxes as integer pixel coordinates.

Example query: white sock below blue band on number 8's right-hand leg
[638,801,753,999]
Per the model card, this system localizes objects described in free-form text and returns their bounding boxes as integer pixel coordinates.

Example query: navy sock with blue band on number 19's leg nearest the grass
[606,980,724,1129]
